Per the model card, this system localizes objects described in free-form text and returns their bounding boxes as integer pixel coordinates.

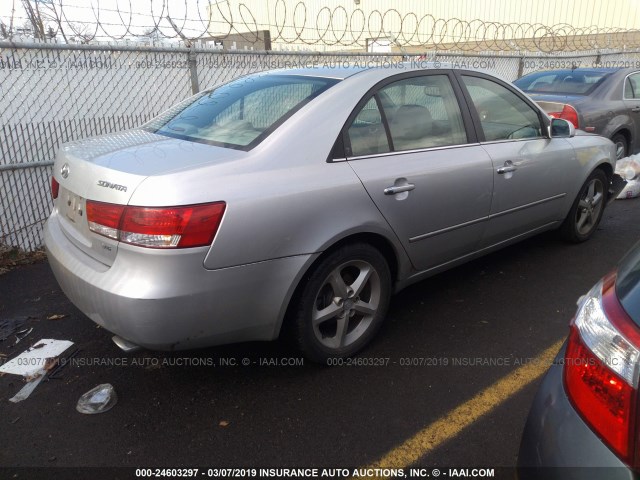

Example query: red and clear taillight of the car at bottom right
[564,275,640,465]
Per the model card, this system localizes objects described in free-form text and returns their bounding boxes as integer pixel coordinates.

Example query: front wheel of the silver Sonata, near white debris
[560,169,609,243]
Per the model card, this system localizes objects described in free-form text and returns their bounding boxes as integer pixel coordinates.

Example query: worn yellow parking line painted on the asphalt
[362,341,562,476]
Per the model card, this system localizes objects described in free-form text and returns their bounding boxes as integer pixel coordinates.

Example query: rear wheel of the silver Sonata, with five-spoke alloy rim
[290,243,391,364]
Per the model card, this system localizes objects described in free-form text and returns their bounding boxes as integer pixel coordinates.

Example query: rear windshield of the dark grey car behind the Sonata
[513,70,611,95]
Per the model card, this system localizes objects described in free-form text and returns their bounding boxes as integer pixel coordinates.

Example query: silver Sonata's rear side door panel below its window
[349,144,493,271]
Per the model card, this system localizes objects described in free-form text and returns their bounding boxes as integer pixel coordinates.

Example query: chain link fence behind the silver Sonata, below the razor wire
[0,42,640,250]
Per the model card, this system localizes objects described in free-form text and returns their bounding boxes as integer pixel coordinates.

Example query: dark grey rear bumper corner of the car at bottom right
[518,347,635,480]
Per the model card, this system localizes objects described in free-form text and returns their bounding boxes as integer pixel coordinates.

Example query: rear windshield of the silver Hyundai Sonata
[143,75,339,150]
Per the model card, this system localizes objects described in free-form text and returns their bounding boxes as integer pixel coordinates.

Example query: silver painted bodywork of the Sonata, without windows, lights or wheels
[45,63,614,349]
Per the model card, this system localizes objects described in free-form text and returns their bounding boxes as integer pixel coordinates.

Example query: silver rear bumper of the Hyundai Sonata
[44,213,314,350]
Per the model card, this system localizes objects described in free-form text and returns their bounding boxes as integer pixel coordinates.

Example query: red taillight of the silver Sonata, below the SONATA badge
[86,200,226,248]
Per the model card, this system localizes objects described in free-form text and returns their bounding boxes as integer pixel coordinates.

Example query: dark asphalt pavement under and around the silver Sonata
[0,199,640,478]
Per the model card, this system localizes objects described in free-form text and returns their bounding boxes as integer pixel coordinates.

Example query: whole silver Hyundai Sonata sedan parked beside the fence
[45,64,621,361]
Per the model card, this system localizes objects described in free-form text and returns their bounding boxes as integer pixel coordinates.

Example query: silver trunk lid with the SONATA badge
[53,129,244,266]
